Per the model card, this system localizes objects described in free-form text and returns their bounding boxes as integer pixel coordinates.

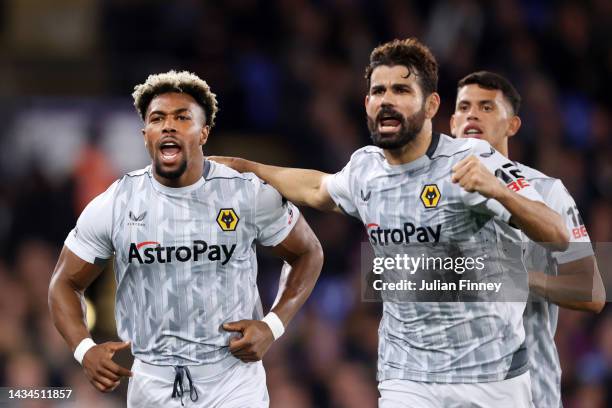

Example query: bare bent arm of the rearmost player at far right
[529,255,606,313]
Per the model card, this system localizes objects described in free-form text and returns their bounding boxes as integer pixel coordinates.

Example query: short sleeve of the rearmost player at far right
[546,180,593,264]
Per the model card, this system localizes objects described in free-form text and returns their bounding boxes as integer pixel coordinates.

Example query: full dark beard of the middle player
[367,104,425,150]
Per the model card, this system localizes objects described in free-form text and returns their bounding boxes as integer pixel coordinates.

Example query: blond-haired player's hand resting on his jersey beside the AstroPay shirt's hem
[223,320,274,363]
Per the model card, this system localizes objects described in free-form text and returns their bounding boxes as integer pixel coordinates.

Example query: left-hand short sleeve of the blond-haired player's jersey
[64,182,118,264]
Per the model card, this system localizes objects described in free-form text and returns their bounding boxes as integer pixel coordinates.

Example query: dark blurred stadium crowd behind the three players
[0,0,612,408]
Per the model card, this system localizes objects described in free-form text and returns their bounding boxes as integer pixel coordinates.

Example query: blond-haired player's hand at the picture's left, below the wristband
[83,341,132,392]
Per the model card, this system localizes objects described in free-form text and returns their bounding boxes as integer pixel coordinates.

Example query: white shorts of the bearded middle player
[378,372,533,408]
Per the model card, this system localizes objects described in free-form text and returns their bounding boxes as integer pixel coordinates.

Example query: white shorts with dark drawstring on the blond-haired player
[127,360,270,408]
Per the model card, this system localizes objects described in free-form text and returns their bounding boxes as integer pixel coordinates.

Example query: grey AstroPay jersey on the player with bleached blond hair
[65,161,299,368]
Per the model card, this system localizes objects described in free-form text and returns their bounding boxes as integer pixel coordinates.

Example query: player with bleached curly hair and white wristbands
[49,71,323,407]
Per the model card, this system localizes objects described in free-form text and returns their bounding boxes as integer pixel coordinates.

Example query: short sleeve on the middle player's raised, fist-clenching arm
[462,142,544,223]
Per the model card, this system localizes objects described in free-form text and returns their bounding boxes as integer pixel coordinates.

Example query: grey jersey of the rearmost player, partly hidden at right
[516,163,593,407]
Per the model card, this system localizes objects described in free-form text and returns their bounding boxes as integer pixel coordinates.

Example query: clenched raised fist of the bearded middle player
[451,156,506,198]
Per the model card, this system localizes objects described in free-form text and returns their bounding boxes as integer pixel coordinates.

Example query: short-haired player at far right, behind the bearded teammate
[451,71,605,407]
